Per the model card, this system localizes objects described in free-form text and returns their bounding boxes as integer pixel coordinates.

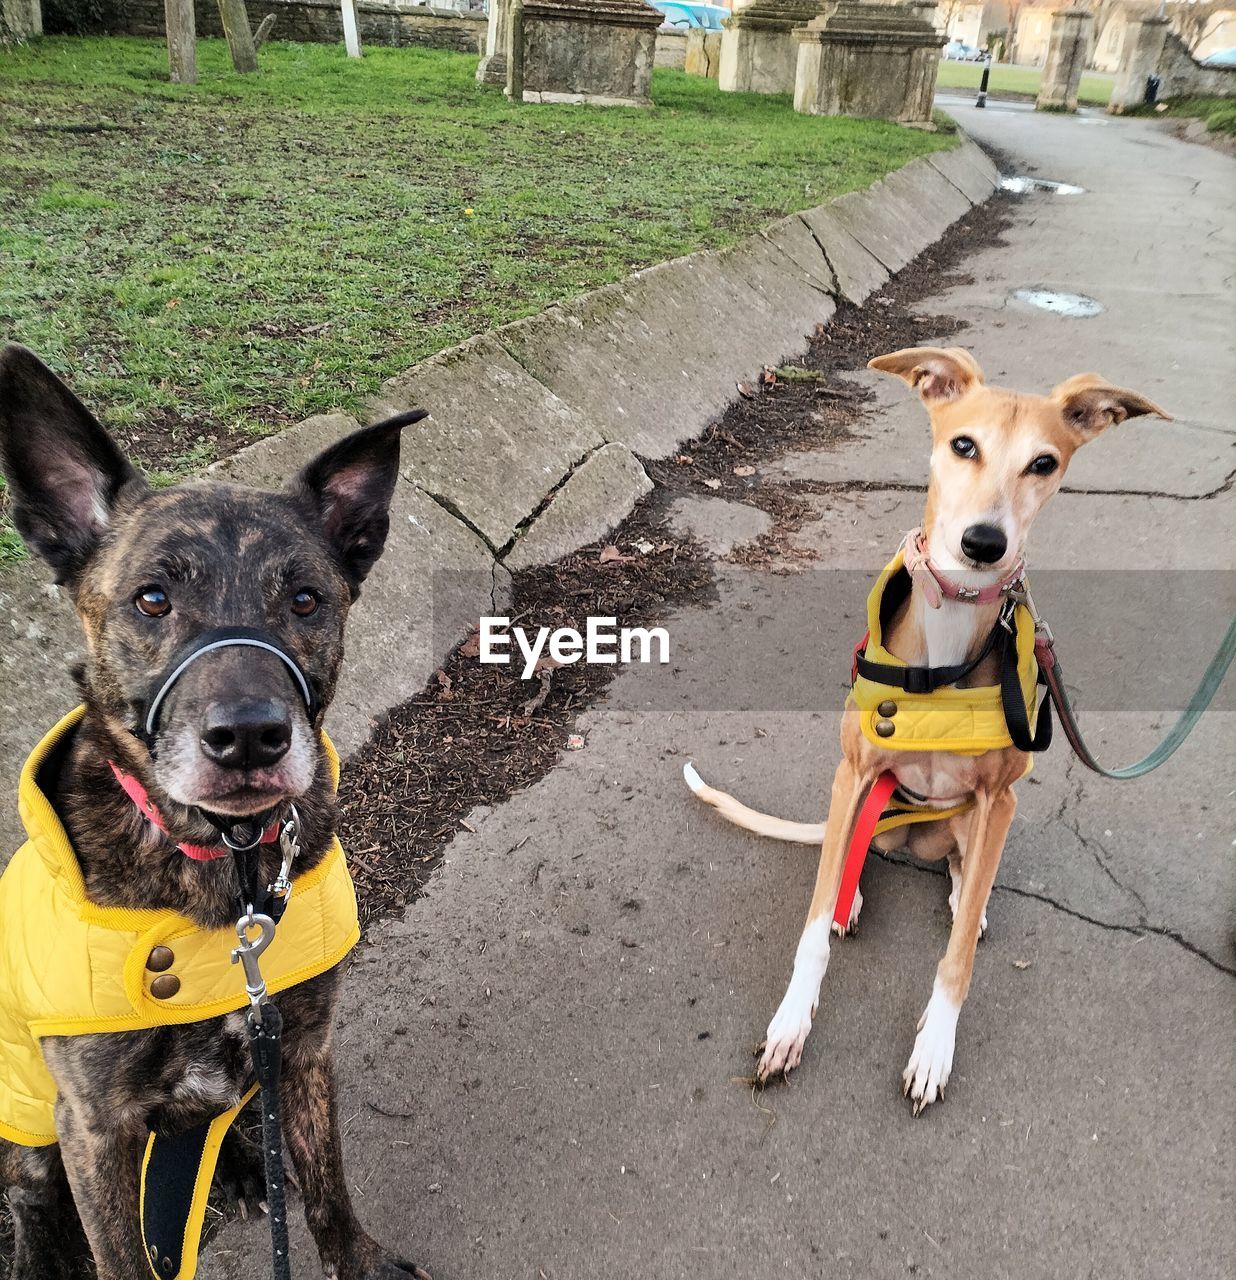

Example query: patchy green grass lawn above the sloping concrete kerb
[0,37,952,558]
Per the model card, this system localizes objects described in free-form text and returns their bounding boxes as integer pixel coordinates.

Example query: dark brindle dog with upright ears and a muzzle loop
[0,346,429,1280]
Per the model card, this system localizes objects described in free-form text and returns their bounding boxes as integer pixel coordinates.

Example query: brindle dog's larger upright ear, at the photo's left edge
[0,343,142,584]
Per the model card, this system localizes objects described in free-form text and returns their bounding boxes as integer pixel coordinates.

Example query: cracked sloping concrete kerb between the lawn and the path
[0,142,998,849]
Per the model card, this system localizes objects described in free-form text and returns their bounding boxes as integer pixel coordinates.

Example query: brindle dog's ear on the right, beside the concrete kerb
[288,408,429,599]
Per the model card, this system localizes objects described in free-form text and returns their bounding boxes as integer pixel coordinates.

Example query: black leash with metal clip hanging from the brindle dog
[223,806,299,1280]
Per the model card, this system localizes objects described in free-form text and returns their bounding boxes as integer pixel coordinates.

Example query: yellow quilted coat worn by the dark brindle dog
[0,707,360,1280]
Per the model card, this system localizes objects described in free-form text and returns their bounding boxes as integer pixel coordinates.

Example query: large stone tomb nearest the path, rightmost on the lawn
[795,0,946,124]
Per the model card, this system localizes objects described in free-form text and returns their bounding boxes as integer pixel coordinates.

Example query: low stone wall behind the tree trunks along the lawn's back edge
[47,0,486,54]
